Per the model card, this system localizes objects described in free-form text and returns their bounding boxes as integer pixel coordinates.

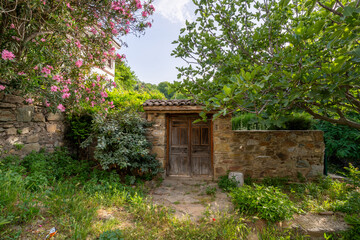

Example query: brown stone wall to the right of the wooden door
[213,117,325,179]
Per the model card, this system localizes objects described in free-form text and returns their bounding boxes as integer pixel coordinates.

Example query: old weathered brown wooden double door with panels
[168,116,212,176]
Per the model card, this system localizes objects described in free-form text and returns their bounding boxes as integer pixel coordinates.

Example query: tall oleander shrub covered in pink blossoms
[0,0,155,111]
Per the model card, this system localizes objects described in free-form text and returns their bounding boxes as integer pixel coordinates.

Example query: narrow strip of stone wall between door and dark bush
[146,113,166,169]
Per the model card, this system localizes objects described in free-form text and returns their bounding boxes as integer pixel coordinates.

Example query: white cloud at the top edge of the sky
[154,0,193,23]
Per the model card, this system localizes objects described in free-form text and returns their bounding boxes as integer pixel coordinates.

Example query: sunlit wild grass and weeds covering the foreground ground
[0,151,360,239]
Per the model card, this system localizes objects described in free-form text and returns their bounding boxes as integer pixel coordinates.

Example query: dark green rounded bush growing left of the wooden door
[81,112,161,178]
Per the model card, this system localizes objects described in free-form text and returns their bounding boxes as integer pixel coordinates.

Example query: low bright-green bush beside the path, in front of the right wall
[230,184,298,222]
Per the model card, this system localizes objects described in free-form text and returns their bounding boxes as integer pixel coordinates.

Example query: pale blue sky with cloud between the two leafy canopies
[120,0,195,84]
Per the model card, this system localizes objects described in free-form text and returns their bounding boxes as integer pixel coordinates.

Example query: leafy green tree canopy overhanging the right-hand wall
[173,0,360,129]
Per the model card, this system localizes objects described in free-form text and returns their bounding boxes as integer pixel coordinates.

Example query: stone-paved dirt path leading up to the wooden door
[151,178,233,220]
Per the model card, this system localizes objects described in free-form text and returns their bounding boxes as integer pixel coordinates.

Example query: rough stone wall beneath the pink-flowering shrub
[0,93,65,157]
